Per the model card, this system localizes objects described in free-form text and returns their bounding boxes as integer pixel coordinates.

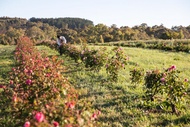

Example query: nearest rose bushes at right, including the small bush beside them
[130,65,189,115]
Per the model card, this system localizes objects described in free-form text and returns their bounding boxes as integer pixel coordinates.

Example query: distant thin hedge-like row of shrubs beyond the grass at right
[96,40,190,53]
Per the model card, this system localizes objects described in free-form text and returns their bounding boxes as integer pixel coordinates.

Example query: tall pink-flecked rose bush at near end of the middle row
[106,47,128,82]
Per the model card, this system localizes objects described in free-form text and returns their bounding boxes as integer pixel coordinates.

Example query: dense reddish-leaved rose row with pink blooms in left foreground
[0,37,101,127]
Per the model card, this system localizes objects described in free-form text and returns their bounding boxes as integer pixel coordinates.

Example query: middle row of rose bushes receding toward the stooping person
[43,44,128,82]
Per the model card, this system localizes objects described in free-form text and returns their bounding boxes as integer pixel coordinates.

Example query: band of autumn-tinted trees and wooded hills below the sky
[0,17,190,44]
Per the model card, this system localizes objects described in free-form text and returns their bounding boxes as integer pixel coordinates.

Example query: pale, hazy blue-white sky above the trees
[0,0,190,28]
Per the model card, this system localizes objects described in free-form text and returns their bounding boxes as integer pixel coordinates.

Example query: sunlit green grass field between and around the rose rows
[0,45,190,127]
